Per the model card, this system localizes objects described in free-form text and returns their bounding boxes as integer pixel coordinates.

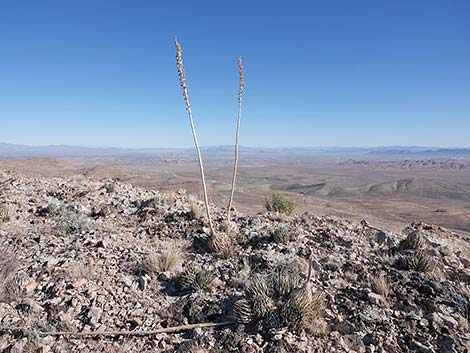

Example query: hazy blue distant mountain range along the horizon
[0,142,470,159]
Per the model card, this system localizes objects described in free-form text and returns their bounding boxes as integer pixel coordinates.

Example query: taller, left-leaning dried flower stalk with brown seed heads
[175,37,215,235]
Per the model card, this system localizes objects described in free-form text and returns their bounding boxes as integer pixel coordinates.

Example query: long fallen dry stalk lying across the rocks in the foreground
[0,321,233,337]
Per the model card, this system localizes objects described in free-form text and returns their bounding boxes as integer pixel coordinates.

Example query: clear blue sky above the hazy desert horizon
[0,0,470,147]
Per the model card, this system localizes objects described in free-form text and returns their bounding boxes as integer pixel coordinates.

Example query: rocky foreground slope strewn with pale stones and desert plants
[0,171,470,352]
